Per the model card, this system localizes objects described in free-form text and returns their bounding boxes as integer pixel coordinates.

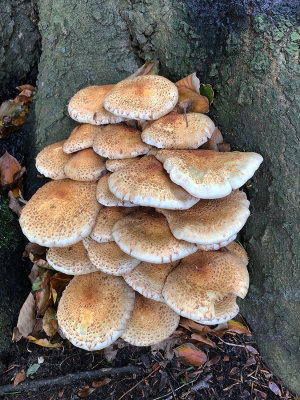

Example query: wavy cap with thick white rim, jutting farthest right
[155,150,263,199]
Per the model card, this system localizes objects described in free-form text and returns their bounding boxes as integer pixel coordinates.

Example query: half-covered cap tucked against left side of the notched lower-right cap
[123,261,179,302]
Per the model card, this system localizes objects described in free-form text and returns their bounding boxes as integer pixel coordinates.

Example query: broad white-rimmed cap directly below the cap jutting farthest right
[157,190,250,250]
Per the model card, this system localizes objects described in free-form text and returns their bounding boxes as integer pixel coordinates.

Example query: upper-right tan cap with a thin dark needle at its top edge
[142,113,215,149]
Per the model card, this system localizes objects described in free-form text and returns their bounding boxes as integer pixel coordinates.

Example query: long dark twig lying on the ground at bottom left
[0,365,142,396]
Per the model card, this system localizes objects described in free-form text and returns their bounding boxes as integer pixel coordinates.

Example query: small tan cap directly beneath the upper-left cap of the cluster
[63,124,102,153]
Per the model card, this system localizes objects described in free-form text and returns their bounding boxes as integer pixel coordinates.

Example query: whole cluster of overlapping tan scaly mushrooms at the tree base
[20,75,262,350]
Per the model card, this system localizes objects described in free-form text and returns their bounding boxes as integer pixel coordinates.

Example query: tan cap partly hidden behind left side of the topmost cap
[68,85,124,125]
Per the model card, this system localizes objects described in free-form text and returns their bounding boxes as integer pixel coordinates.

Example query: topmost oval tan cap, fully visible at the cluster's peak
[103,75,178,120]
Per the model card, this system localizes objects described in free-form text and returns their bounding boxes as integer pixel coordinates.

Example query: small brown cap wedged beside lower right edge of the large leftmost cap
[90,207,134,243]
